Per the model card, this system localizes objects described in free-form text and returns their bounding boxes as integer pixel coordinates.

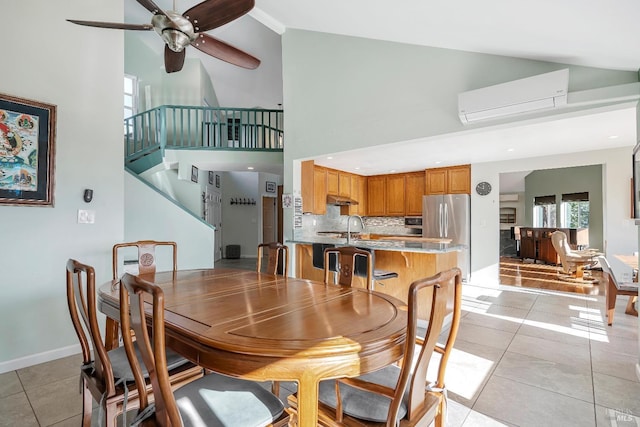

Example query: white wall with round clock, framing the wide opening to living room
[471,148,638,285]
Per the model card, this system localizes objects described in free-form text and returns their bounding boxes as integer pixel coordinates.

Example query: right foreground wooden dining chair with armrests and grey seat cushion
[289,268,462,427]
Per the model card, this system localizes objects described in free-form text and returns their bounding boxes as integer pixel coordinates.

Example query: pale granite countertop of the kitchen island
[287,236,465,253]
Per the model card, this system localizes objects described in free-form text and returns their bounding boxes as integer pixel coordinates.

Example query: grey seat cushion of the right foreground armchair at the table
[318,365,409,423]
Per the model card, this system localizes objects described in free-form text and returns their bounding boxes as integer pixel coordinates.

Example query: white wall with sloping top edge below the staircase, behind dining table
[124,173,214,271]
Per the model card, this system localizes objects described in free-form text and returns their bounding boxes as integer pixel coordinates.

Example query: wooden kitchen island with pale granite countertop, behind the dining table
[287,236,464,319]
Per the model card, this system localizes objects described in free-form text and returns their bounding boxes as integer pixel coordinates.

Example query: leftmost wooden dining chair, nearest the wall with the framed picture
[66,259,202,427]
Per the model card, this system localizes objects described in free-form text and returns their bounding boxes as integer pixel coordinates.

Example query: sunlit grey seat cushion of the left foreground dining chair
[174,373,284,427]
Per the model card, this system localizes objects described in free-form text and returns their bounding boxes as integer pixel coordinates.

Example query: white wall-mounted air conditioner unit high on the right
[458,69,569,124]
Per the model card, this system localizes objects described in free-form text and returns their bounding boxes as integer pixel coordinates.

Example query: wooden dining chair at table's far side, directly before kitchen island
[324,246,373,290]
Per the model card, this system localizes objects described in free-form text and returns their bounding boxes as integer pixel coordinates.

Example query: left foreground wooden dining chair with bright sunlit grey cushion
[120,273,289,427]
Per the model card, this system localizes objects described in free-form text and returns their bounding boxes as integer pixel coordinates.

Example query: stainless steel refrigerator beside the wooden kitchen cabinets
[422,194,471,281]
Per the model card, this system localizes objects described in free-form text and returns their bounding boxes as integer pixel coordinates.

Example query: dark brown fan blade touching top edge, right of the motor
[182,0,255,33]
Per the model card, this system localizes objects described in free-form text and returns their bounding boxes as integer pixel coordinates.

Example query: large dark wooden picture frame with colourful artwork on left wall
[0,93,57,207]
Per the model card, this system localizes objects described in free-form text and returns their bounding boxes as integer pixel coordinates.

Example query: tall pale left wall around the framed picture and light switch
[0,0,124,372]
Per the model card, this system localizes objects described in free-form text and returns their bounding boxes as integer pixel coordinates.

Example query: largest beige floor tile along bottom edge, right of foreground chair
[472,376,595,427]
